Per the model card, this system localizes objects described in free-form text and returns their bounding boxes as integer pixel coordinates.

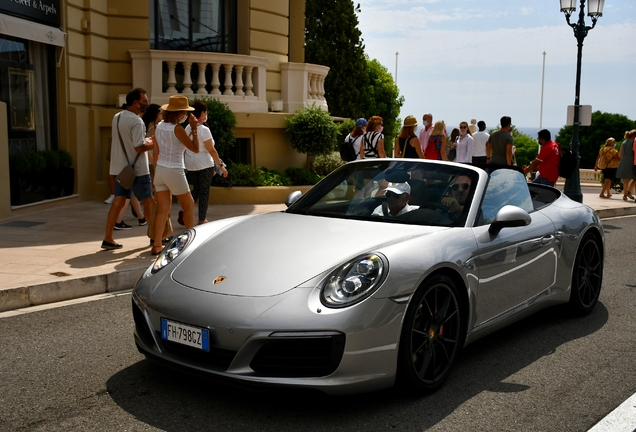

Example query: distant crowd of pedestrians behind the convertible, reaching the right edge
[341,113,636,197]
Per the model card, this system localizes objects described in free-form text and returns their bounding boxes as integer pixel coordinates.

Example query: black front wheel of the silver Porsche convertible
[398,275,465,393]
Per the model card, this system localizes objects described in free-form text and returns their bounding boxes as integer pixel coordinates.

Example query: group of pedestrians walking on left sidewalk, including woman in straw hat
[101,88,227,255]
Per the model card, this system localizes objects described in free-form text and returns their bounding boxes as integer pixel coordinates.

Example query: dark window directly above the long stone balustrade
[150,0,236,54]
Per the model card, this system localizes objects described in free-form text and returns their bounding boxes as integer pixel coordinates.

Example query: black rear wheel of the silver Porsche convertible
[570,235,603,315]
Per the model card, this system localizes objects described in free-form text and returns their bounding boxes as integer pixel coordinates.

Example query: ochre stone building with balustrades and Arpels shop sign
[0,0,328,219]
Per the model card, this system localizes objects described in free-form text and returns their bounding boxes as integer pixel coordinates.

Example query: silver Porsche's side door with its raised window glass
[473,169,558,325]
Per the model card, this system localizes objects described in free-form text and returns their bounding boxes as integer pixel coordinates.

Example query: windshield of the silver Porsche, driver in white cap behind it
[287,159,479,226]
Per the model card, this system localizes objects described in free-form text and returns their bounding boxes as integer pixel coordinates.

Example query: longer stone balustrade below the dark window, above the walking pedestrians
[129,50,269,112]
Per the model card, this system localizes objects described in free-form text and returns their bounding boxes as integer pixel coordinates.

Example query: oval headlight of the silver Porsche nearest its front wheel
[320,254,386,308]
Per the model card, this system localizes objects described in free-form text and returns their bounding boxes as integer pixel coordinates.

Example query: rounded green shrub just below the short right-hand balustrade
[285,104,338,156]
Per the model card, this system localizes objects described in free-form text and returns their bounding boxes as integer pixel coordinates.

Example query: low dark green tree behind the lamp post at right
[555,111,636,169]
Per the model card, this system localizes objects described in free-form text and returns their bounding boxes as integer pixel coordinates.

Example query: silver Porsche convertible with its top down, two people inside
[132,159,604,394]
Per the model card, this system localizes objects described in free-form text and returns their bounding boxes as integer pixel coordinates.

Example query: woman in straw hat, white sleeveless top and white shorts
[150,95,199,255]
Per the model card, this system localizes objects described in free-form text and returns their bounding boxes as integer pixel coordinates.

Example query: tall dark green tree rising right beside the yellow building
[305,0,367,118]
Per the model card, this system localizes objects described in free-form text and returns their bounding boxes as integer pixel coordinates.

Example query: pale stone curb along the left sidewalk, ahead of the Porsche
[0,266,148,312]
